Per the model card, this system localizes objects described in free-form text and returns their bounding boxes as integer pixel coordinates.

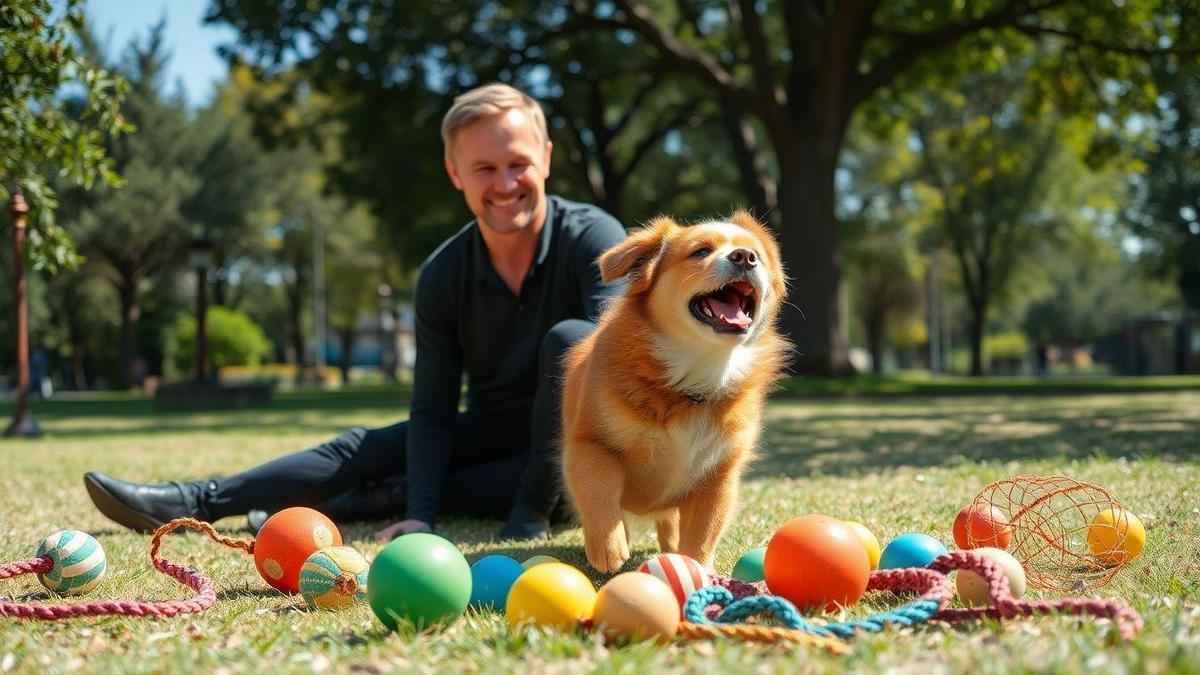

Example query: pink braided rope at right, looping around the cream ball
[704,551,1142,640]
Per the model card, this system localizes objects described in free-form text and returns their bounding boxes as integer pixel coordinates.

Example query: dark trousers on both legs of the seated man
[199,319,595,520]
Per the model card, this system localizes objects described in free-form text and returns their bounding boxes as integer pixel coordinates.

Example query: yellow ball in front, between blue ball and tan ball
[505,562,596,631]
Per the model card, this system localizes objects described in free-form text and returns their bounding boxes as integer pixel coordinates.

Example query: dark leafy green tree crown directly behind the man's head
[211,0,770,269]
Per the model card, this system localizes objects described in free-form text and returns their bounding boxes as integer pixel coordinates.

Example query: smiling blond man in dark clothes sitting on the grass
[84,84,625,539]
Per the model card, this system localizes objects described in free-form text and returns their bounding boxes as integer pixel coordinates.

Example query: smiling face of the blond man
[445,108,551,234]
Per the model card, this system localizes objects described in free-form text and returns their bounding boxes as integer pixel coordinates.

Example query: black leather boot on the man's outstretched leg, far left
[83,471,208,532]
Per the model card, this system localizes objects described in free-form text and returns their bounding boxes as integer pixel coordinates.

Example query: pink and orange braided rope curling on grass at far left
[0,518,232,621]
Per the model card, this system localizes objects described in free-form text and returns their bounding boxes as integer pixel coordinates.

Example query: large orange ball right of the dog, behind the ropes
[763,514,871,611]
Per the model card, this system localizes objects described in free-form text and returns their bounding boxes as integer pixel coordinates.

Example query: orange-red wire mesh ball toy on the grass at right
[969,476,1129,593]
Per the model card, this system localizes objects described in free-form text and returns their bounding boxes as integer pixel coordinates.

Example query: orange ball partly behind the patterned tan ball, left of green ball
[254,507,342,593]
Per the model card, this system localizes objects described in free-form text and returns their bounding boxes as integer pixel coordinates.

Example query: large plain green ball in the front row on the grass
[367,532,470,631]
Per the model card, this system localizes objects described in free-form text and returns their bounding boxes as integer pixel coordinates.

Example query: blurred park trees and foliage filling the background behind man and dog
[0,0,1200,388]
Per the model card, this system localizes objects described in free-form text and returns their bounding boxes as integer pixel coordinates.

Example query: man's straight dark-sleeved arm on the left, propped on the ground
[407,267,462,525]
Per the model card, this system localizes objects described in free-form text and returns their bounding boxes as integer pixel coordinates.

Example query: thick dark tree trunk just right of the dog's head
[775,133,851,376]
